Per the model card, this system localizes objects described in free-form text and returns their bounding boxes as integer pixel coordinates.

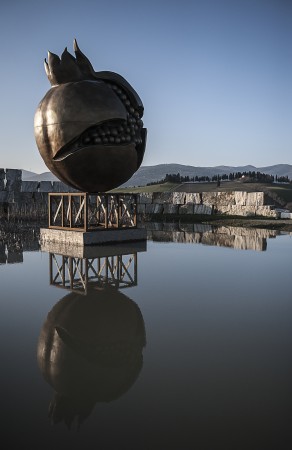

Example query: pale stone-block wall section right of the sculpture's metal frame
[138,191,279,217]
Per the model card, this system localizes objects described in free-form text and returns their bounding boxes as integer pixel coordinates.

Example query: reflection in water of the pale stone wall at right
[145,223,279,251]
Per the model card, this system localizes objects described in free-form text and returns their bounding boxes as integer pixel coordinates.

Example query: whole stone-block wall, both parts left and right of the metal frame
[0,169,279,219]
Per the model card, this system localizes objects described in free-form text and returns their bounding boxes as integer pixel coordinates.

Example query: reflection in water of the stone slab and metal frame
[41,241,146,294]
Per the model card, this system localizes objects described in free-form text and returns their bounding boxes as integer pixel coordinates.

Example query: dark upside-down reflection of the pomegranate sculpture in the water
[38,287,146,427]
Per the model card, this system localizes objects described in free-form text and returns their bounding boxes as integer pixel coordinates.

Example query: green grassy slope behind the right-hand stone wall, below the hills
[111,181,292,208]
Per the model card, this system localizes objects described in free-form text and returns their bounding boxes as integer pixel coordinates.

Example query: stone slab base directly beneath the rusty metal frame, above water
[40,228,147,247]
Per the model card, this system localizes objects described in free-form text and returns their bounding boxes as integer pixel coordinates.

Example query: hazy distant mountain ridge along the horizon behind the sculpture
[22,164,292,187]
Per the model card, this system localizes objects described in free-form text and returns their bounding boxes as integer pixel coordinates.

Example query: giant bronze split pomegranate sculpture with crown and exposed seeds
[34,40,146,193]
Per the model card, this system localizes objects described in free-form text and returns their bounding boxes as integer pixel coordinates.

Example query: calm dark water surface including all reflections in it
[0,224,292,450]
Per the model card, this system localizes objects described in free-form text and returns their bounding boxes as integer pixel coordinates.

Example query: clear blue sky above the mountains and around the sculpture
[0,0,292,173]
